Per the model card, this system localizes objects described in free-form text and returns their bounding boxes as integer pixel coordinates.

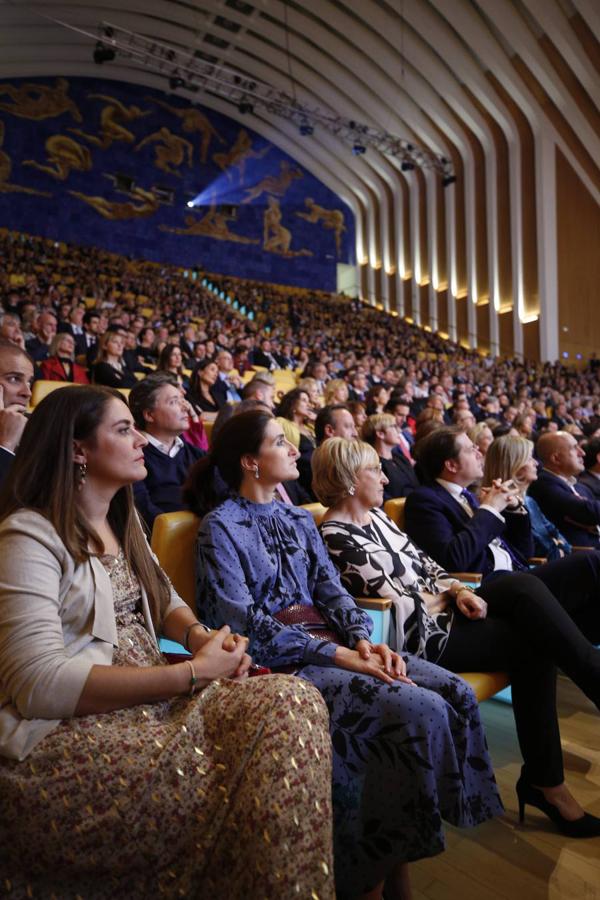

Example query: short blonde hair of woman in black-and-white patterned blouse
[311,438,379,507]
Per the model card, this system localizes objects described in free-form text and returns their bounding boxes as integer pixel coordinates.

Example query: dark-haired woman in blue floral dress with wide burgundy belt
[186,410,501,898]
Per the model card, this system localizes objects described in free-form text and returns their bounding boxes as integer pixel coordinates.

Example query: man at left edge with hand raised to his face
[0,340,33,484]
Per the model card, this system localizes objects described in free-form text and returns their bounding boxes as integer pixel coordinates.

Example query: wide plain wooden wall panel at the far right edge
[556,149,600,361]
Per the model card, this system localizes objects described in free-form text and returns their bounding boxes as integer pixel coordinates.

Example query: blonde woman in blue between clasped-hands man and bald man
[483,434,571,560]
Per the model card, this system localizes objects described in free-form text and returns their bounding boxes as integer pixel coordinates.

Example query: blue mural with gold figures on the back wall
[0,77,355,290]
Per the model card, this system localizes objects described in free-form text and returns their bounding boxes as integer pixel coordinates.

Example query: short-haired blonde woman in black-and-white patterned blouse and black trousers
[313,438,600,837]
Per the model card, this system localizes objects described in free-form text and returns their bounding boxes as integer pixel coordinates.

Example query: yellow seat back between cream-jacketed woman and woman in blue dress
[151,510,200,612]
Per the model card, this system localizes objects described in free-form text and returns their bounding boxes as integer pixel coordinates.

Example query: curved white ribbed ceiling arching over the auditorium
[0,0,600,356]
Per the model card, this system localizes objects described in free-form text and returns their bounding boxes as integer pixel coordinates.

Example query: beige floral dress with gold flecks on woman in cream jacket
[0,555,334,900]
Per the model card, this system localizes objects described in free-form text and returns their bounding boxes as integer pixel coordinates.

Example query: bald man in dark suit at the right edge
[529,431,600,549]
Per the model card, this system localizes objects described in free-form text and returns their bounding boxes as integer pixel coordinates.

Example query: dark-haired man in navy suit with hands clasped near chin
[405,427,600,616]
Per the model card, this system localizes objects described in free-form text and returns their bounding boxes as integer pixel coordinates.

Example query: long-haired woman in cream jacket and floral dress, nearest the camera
[0,387,334,900]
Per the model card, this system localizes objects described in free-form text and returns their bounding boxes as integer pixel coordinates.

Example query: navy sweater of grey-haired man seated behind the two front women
[133,441,204,529]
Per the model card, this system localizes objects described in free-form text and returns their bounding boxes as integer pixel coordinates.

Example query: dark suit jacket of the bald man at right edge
[529,469,600,549]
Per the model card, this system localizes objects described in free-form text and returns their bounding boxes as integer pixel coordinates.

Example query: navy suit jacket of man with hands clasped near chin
[405,483,533,575]
